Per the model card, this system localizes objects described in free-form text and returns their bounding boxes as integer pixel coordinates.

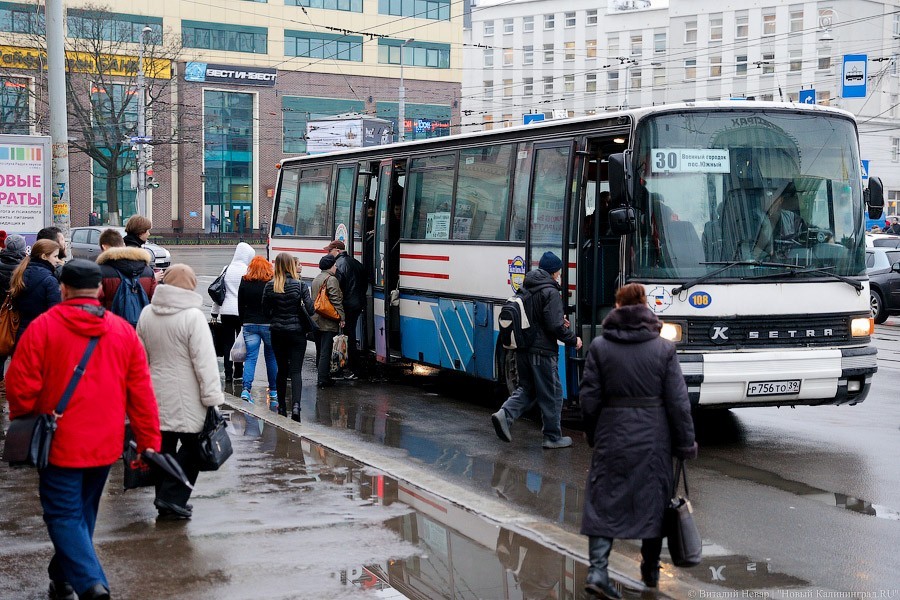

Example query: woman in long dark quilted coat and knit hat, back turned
[581,283,697,599]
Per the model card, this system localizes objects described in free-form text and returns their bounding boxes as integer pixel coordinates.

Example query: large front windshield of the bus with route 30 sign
[632,110,865,280]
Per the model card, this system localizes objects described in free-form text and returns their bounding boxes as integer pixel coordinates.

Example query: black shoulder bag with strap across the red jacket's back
[3,337,100,469]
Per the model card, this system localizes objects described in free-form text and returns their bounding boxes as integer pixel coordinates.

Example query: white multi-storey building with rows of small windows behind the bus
[461,0,900,214]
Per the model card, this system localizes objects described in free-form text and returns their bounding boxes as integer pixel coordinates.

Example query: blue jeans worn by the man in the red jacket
[39,465,109,595]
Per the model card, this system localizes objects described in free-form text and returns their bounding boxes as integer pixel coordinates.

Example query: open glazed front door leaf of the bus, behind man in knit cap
[528,141,575,394]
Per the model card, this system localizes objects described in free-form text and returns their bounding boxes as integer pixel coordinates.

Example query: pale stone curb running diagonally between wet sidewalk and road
[225,392,700,600]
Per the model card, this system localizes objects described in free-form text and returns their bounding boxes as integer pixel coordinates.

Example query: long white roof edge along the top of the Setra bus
[281,100,856,167]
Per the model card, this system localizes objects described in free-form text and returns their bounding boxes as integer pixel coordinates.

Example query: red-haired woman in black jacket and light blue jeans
[238,256,278,410]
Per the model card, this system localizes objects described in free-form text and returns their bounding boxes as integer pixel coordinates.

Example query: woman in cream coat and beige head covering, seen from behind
[137,264,225,519]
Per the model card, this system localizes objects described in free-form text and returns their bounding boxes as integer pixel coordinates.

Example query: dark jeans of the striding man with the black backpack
[503,352,562,442]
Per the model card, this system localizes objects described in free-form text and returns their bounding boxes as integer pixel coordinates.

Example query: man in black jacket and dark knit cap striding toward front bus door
[491,252,581,449]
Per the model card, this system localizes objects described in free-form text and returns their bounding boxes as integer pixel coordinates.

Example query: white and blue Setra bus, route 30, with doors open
[269,102,883,408]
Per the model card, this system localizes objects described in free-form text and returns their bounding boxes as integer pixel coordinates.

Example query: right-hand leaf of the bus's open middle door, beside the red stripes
[372,159,406,362]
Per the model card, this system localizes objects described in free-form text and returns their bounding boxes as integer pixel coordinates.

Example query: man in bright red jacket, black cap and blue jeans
[6,259,161,600]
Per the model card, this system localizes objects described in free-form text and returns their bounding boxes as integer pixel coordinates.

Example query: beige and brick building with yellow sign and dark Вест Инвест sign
[0,0,462,233]
